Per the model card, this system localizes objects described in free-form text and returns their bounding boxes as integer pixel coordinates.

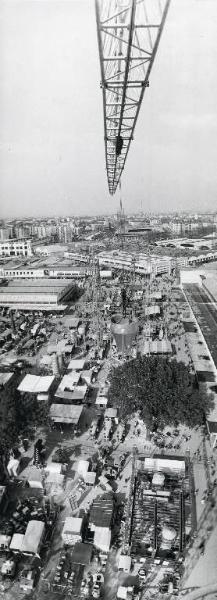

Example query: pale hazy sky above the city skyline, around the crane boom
[0,0,217,217]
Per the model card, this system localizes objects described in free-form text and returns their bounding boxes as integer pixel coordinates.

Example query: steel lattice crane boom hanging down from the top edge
[95,0,170,194]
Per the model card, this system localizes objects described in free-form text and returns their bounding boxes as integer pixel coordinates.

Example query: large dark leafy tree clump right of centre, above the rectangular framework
[109,356,213,430]
